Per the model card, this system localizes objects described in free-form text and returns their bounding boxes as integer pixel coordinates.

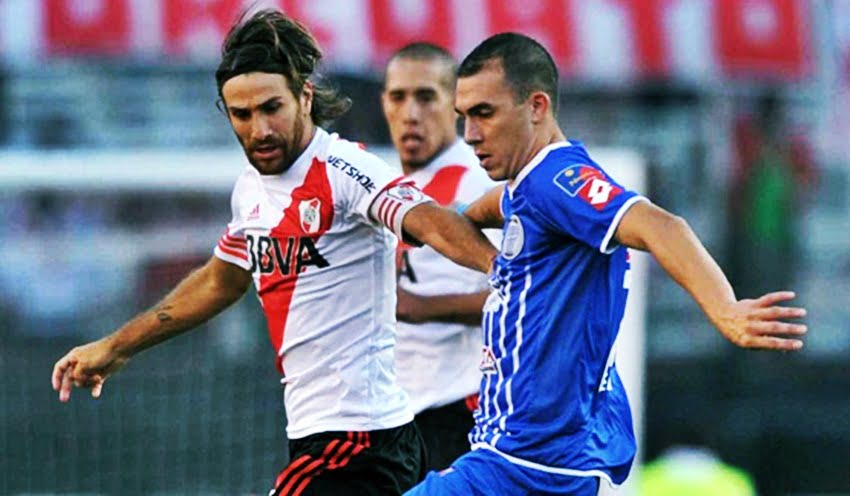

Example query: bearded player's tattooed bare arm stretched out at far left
[52,257,251,402]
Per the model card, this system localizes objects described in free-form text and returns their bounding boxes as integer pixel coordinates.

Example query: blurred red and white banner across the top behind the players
[24,0,812,82]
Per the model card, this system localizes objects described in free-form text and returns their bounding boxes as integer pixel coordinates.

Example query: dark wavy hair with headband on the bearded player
[215,9,351,125]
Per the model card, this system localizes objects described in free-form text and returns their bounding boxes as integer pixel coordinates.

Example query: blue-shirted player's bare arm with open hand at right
[615,202,807,350]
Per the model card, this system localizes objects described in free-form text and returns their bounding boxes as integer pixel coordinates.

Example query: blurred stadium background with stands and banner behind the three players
[0,0,850,496]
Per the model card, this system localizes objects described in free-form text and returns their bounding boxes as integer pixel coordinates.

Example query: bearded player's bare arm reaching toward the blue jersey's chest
[402,202,497,273]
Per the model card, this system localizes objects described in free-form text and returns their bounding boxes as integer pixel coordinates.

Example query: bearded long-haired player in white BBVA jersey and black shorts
[52,10,496,495]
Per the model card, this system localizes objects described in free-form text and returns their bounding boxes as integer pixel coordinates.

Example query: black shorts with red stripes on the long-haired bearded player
[269,422,426,496]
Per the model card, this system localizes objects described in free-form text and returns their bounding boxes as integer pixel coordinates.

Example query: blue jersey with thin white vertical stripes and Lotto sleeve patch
[470,142,645,484]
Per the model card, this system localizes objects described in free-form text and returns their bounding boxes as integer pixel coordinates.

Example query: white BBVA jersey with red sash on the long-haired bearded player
[215,128,429,439]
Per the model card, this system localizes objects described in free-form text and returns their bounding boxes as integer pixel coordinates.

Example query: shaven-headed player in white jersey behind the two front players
[381,43,499,470]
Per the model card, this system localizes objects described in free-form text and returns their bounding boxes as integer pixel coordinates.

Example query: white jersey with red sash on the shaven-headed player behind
[396,139,501,413]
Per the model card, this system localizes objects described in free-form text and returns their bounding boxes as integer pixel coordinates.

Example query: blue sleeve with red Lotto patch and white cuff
[524,151,648,253]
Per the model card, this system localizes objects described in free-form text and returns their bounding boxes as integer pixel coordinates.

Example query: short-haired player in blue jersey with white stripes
[408,33,806,496]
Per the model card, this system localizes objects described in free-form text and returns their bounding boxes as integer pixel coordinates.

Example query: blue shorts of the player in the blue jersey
[404,449,599,496]
